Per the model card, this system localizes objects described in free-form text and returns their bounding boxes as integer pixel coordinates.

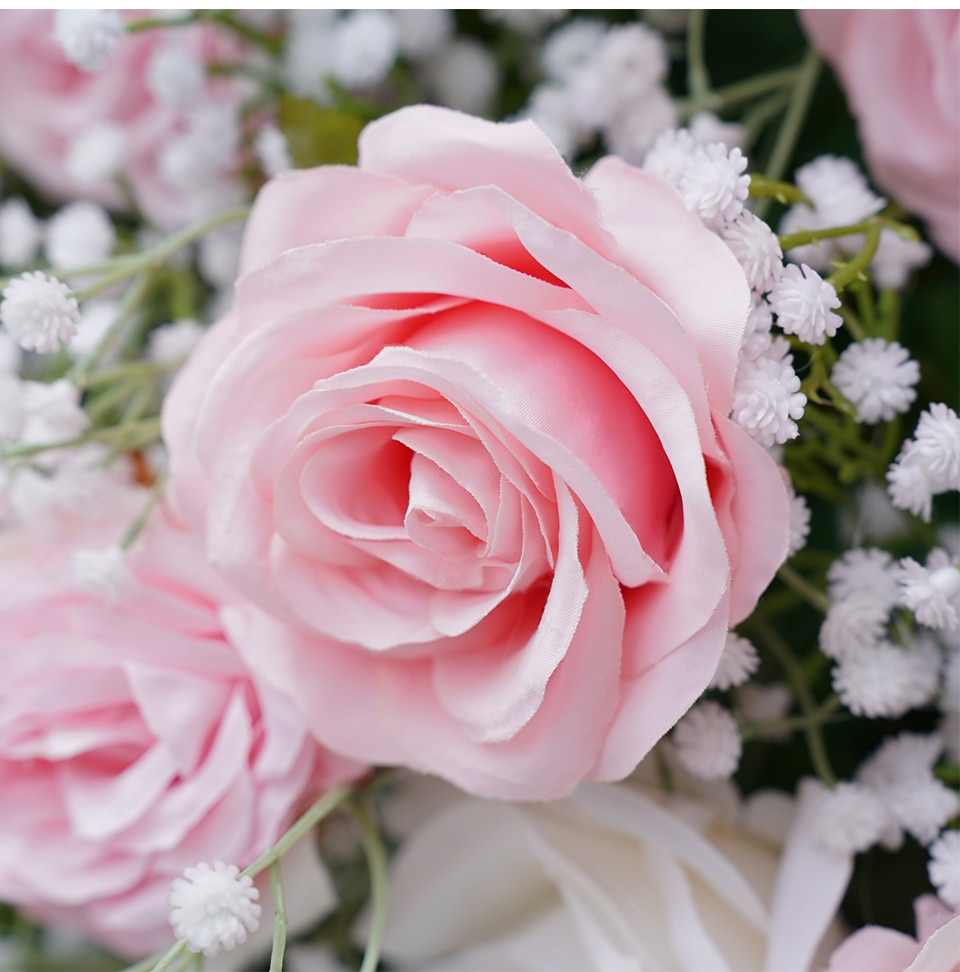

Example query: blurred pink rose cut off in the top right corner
[800,9,960,262]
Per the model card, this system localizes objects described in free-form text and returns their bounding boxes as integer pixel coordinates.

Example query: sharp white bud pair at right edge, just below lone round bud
[887,402,960,523]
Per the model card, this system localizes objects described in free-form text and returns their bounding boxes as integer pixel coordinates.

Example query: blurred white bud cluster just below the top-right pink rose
[780,155,933,289]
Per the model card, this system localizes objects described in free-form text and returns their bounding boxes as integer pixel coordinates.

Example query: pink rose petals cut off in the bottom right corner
[827,894,960,972]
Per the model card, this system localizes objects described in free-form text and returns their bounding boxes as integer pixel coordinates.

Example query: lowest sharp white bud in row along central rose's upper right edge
[730,338,807,448]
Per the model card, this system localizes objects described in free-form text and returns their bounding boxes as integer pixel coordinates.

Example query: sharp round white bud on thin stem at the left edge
[0,270,80,353]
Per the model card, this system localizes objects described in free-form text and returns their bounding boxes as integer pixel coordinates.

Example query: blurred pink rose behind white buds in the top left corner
[0,10,242,228]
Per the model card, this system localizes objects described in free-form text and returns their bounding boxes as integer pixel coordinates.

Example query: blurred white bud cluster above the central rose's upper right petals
[523,18,677,163]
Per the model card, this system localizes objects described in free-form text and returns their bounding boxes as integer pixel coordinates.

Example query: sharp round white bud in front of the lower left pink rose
[169,861,260,956]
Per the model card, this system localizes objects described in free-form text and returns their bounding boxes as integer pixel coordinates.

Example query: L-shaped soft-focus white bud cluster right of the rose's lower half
[820,548,943,718]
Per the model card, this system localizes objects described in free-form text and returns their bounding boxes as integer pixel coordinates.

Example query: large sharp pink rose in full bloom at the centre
[164,107,788,798]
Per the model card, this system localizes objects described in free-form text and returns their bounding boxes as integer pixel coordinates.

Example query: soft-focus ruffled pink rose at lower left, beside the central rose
[0,514,357,956]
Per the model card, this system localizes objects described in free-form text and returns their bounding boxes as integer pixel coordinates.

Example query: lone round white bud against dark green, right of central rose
[830,338,920,425]
